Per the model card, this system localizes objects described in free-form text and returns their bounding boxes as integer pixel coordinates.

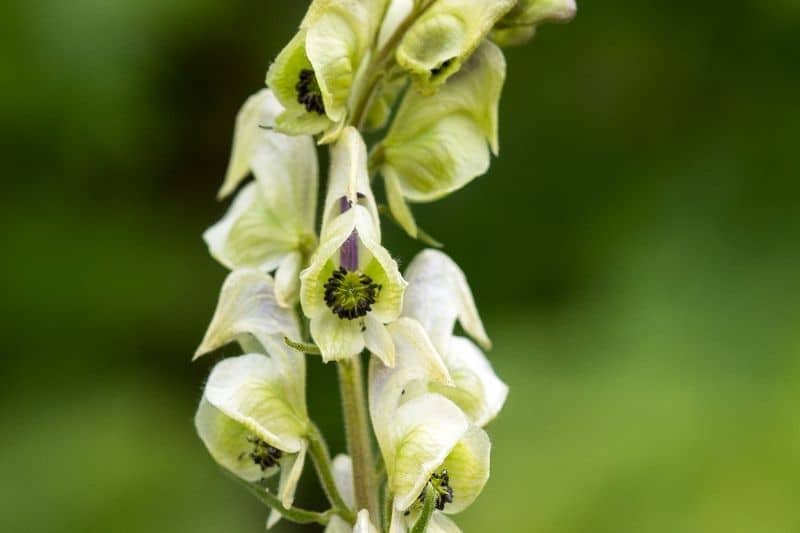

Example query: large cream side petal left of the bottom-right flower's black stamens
[384,394,469,510]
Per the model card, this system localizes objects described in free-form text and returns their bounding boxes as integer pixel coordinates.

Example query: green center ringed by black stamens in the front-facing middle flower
[323,266,381,320]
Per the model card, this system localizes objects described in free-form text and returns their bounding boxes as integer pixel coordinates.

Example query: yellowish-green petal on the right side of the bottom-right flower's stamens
[442,426,491,514]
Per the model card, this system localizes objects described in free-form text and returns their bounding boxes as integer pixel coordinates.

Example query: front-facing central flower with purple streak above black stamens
[300,128,406,366]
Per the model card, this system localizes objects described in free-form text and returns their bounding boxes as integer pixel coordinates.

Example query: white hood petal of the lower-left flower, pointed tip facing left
[195,269,299,359]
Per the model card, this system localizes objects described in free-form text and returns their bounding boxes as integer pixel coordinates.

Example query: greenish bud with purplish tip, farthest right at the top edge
[491,0,577,46]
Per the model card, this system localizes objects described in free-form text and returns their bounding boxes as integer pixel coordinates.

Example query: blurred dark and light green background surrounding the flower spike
[0,0,800,533]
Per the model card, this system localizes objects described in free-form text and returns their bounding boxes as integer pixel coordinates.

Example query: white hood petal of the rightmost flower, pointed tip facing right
[403,249,491,352]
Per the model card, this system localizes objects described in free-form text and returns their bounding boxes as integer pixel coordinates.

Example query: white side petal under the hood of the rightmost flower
[431,337,508,427]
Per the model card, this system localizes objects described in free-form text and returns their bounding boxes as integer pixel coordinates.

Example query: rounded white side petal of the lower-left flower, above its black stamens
[204,354,308,453]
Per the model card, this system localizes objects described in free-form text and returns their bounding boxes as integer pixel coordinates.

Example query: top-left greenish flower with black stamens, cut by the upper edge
[267,0,386,138]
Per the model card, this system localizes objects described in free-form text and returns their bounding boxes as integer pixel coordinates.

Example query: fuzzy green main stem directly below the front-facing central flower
[338,355,378,517]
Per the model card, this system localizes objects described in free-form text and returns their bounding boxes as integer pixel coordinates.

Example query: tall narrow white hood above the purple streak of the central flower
[322,127,380,233]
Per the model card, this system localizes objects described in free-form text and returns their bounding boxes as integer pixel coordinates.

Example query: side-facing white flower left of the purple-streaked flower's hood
[203,89,318,306]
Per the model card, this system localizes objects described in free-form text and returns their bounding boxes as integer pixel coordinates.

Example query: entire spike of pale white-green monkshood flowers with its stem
[195,0,575,533]
